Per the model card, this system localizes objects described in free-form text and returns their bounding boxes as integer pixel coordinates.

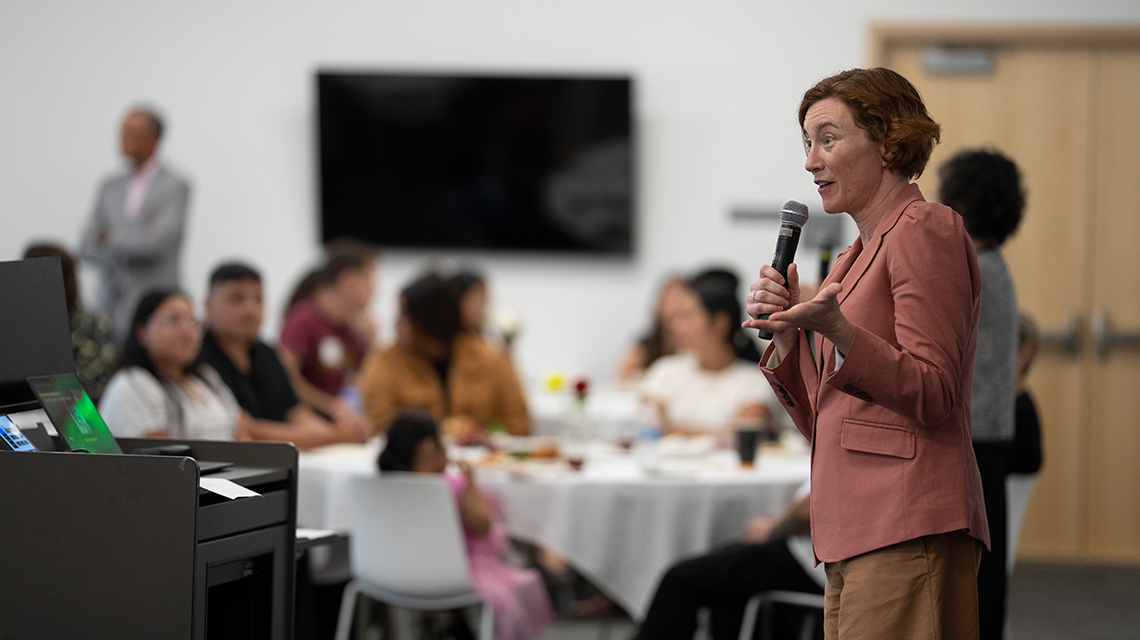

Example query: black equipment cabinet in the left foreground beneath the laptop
[0,438,296,640]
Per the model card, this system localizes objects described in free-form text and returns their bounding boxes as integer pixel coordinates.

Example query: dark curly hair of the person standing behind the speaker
[938,149,1025,246]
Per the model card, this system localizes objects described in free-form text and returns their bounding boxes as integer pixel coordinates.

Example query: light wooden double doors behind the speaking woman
[874,30,1140,561]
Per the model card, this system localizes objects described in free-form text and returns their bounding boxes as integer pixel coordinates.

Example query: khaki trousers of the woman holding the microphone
[823,532,983,640]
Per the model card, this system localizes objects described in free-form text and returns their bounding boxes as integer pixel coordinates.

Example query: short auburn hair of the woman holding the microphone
[799,66,942,178]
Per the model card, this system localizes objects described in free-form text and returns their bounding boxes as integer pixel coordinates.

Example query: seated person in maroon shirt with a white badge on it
[277,240,377,429]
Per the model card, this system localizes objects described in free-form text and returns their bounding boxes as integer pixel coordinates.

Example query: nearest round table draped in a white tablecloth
[298,440,809,619]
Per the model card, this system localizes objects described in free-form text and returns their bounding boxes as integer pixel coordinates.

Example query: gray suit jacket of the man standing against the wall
[80,165,190,343]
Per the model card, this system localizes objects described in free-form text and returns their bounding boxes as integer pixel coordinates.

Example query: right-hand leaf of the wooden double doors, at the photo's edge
[1089,49,1140,562]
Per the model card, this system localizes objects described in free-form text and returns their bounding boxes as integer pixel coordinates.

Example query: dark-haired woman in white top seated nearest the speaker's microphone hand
[641,269,774,435]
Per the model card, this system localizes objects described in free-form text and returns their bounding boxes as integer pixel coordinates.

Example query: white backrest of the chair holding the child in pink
[349,472,472,597]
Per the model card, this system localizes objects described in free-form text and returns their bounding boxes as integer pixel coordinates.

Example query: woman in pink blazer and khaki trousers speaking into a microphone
[744,68,990,640]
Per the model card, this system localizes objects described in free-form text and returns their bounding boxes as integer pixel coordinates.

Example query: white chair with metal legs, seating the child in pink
[336,472,494,640]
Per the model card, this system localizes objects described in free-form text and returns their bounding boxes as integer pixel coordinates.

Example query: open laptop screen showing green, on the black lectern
[27,373,123,453]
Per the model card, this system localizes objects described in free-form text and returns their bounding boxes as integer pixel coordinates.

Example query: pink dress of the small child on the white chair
[445,475,552,640]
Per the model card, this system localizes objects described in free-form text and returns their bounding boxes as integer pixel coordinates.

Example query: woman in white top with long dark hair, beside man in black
[99,291,243,440]
